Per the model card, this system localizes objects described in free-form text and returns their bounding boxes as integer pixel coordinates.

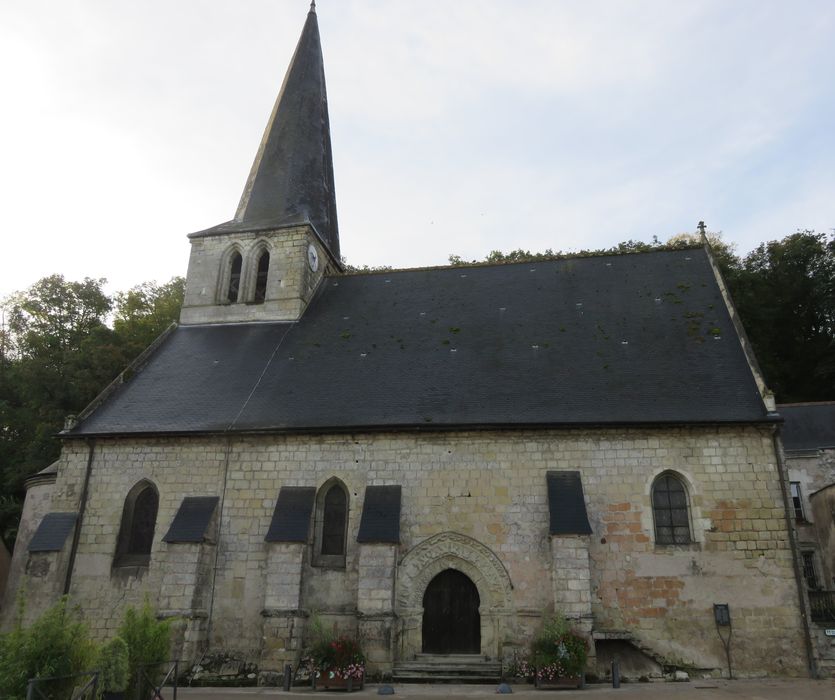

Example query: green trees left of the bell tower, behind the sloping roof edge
[0,275,184,547]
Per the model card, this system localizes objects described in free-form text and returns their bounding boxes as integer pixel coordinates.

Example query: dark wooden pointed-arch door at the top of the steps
[422,569,481,654]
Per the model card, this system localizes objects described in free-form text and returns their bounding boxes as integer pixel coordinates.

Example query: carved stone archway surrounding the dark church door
[395,532,513,660]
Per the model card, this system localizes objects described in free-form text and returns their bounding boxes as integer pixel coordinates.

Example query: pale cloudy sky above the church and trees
[0,0,835,299]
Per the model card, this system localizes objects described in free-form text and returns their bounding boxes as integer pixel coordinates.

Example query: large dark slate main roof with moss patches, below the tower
[65,249,774,436]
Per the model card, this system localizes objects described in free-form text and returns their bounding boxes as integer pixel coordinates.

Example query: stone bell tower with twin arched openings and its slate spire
[180,2,342,325]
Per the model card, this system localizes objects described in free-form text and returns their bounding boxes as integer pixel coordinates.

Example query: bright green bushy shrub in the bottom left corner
[0,598,96,700]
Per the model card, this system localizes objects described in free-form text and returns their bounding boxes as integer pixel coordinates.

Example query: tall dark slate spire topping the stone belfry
[232,1,339,260]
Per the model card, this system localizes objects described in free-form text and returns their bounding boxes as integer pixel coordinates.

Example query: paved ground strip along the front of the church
[175,679,835,700]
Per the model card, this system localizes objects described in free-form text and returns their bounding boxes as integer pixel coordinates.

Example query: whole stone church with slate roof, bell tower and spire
[3,5,814,676]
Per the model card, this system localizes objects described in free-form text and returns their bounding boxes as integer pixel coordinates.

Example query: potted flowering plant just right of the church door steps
[529,615,589,688]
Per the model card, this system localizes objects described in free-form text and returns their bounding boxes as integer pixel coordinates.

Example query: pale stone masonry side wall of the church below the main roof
[8,427,805,675]
